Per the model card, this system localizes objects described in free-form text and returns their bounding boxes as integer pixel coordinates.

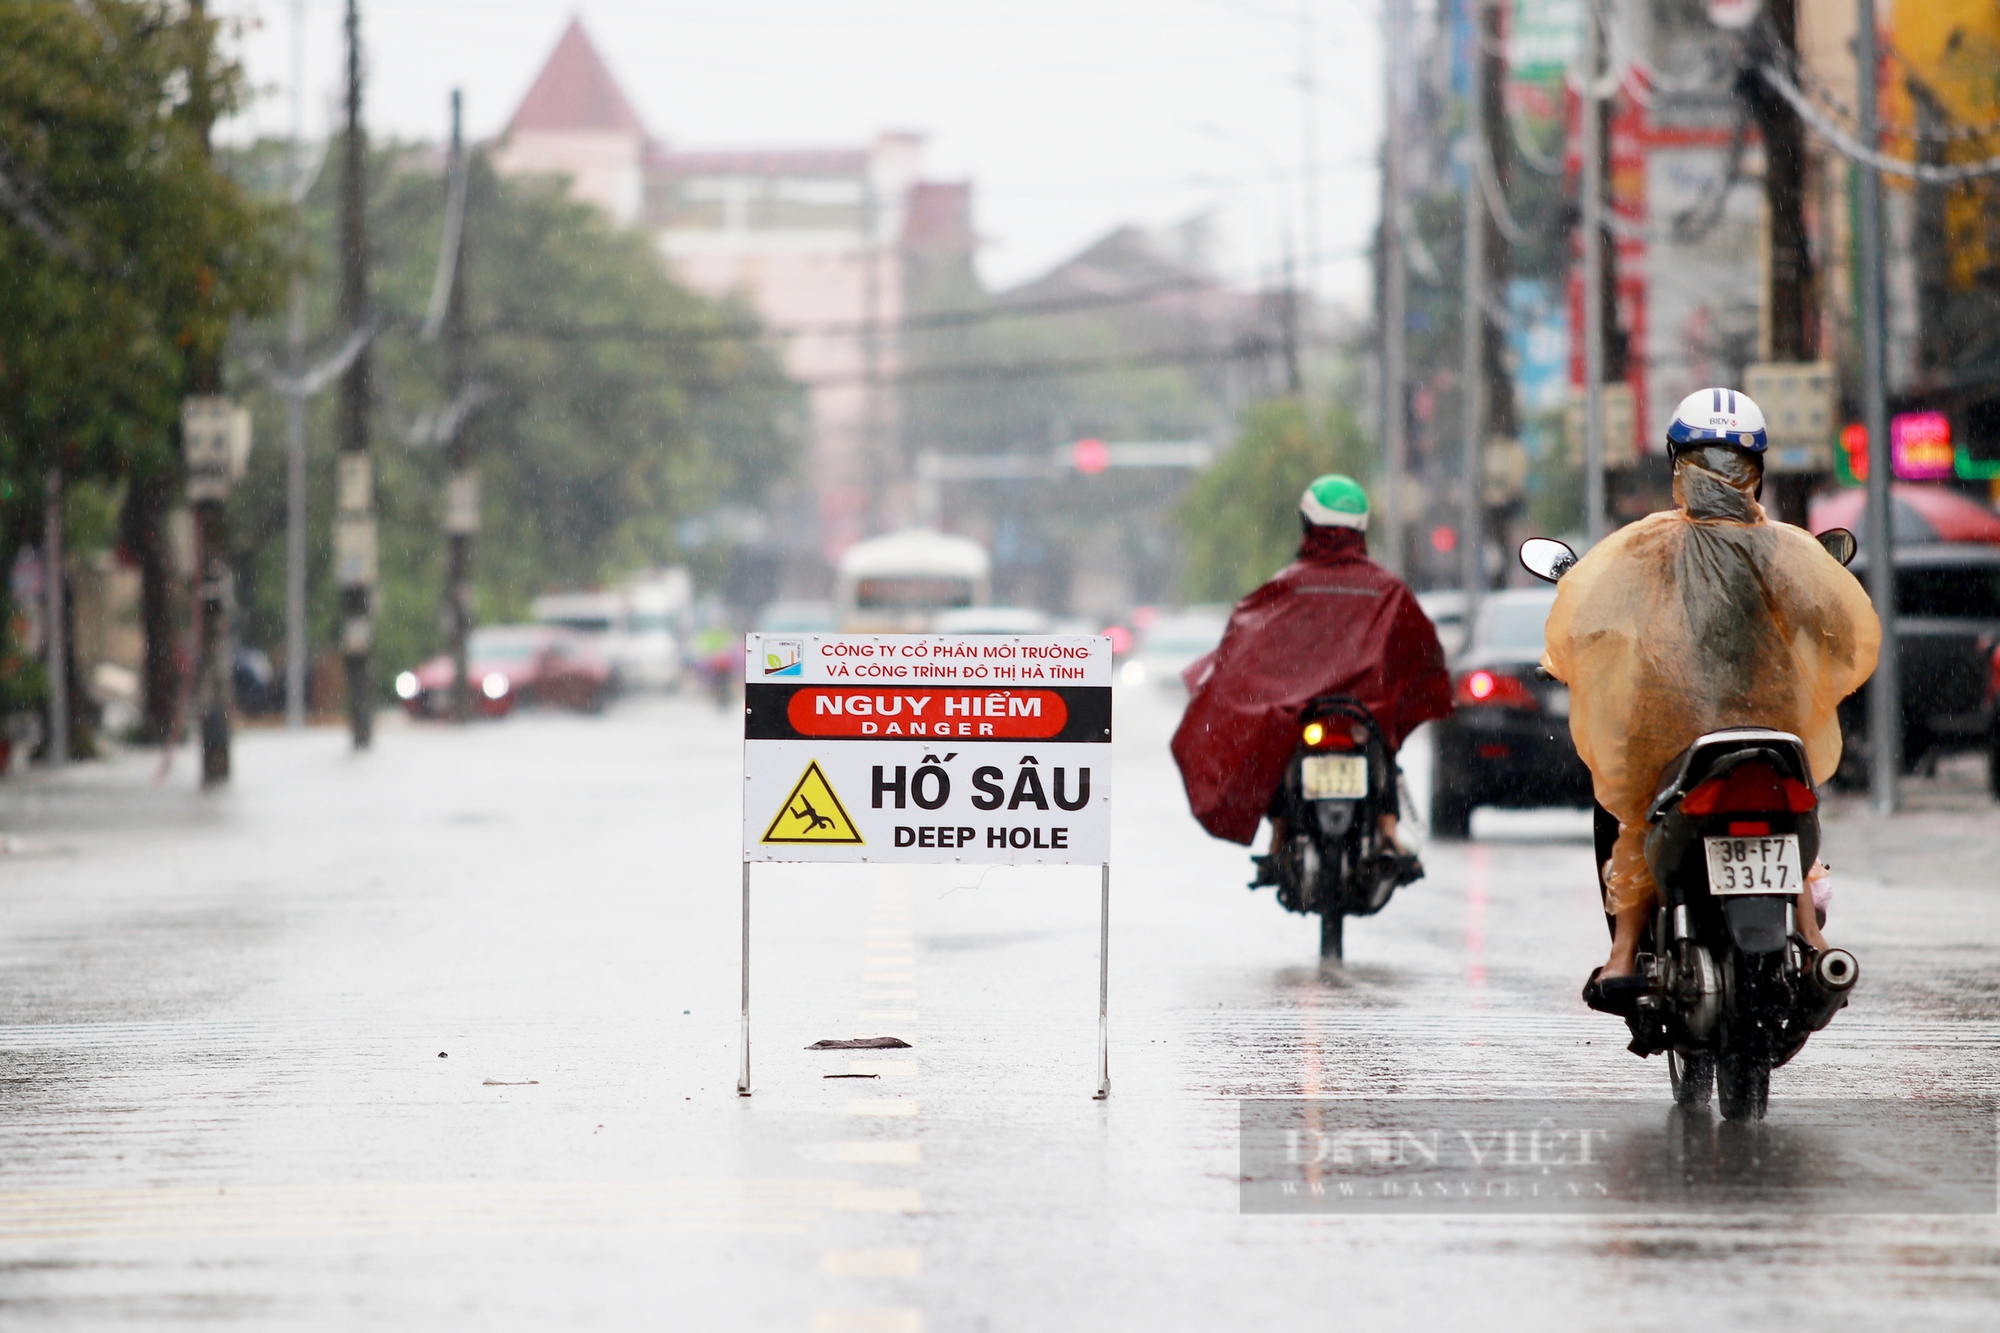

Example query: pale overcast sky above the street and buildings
[214,0,1382,310]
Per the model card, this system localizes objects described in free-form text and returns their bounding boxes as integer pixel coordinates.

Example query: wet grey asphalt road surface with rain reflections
[0,691,2000,1333]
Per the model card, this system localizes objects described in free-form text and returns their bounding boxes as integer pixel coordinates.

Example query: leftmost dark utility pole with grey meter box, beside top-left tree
[182,0,236,787]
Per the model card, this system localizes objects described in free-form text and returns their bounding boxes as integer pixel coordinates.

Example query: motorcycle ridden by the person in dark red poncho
[1250,695,1424,961]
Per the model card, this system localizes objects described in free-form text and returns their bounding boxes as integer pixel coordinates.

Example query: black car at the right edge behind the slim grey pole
[1836,542,2000,795]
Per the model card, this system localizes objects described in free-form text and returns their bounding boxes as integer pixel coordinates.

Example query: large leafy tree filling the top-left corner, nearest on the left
[0,0,282,733]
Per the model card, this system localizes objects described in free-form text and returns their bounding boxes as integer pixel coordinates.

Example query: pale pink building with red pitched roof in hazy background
[494,20,972,560]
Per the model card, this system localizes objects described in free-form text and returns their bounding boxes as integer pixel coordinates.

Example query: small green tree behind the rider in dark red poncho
[1180,398,1376,602]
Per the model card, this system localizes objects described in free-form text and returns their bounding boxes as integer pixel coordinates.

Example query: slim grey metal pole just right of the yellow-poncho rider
[1854,0,1902,817]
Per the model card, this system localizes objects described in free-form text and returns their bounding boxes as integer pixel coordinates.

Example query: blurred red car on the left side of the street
[396,624,612,717]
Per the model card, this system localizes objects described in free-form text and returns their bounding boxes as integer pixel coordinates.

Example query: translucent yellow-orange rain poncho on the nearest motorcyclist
[1542,456,1882,913]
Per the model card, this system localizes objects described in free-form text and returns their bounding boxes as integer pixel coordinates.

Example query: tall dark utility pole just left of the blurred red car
[334,0,376,751]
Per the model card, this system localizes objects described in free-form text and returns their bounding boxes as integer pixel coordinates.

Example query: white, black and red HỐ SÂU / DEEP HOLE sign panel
[744,634,1112,865]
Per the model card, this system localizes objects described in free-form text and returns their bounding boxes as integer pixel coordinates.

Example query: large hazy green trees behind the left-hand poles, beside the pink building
[232,142,802,681]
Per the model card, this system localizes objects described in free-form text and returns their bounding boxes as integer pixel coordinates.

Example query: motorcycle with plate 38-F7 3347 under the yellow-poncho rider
[1520,528,1860,1121]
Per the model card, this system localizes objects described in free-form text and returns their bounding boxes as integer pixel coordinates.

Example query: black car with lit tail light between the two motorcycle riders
[1430,588,1592,839]
